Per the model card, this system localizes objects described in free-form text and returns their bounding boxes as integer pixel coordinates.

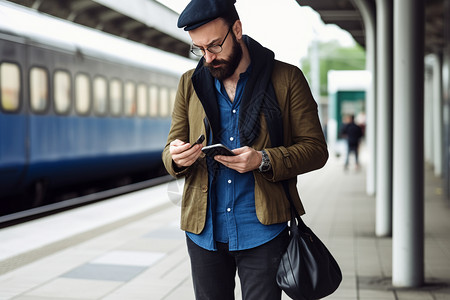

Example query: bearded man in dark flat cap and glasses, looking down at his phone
[163,0,328,300]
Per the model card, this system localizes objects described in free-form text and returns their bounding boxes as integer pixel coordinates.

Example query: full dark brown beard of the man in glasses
[204,32,242,81]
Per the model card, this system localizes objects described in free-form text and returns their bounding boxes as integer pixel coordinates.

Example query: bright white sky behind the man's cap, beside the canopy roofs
[157,0,355,66]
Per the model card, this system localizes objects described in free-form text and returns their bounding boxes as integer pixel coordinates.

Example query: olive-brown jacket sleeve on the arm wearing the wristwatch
[264,67,328,182]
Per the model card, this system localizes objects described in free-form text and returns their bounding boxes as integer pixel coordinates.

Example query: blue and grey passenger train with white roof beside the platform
[0,1,196,210]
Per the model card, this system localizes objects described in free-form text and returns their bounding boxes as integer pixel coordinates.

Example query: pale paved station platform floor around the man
[0,157,450,300]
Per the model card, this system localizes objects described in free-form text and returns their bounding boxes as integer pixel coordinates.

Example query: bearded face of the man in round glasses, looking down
[189,19,242,80]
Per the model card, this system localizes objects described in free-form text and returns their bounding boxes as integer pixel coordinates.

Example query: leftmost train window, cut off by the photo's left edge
[0,62,20,112]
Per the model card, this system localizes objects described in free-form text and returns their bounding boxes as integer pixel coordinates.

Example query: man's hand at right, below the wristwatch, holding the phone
[214,146,262,173]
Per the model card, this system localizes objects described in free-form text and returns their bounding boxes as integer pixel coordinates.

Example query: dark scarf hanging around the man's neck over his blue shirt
[192,36,283,147]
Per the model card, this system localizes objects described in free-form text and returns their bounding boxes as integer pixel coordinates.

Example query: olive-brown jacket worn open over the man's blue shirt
[163,61,328,234]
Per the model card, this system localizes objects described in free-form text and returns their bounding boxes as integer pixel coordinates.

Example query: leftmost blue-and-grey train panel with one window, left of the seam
[0,35,28,199]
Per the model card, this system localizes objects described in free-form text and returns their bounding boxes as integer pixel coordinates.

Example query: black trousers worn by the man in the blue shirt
[186,229,289,300]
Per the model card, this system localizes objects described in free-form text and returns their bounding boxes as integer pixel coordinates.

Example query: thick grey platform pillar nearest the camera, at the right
[392,0,425,287]
